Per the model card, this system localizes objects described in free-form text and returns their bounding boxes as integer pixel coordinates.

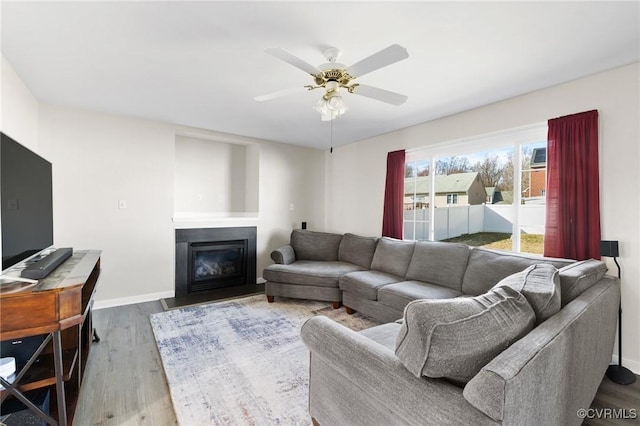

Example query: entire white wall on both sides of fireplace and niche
[33,104,324,305]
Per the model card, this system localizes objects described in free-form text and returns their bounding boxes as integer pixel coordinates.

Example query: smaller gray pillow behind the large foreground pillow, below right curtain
[494,263,560,324]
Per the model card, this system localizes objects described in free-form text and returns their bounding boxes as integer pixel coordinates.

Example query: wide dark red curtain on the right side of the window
[544,110,600,260]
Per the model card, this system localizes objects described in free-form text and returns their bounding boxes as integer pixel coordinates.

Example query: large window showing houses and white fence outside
[404,123,547,254]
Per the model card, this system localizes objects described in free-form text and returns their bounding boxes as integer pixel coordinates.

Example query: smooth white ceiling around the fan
[0,1,640,149]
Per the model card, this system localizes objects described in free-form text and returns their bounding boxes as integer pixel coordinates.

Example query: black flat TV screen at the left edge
[0,133,53,270]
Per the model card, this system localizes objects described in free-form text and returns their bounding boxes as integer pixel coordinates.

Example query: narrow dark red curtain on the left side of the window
[382,149,405,239]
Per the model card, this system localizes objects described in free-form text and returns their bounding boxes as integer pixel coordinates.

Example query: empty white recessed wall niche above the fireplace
[174,135,259,217]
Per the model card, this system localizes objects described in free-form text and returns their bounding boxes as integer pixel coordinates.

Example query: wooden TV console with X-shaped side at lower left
[0,250,101,426]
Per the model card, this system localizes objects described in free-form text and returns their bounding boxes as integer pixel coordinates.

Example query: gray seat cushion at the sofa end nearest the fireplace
[262,260,362,288]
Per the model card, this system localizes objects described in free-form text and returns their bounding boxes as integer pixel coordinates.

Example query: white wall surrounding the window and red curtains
[326,64,640,373]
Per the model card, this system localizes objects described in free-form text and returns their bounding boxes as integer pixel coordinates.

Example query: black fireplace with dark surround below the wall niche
[175,227,256,300]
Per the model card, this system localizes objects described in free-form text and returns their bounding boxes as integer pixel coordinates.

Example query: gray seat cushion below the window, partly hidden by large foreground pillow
[378,281,462,311]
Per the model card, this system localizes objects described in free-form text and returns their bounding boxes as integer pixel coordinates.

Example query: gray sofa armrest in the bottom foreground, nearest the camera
[301,316,495,425]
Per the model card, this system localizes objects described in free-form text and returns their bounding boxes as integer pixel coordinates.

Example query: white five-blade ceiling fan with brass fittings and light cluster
[254,44,409,121]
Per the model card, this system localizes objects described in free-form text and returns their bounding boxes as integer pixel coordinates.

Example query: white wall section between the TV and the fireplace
[38,108,175,301]
